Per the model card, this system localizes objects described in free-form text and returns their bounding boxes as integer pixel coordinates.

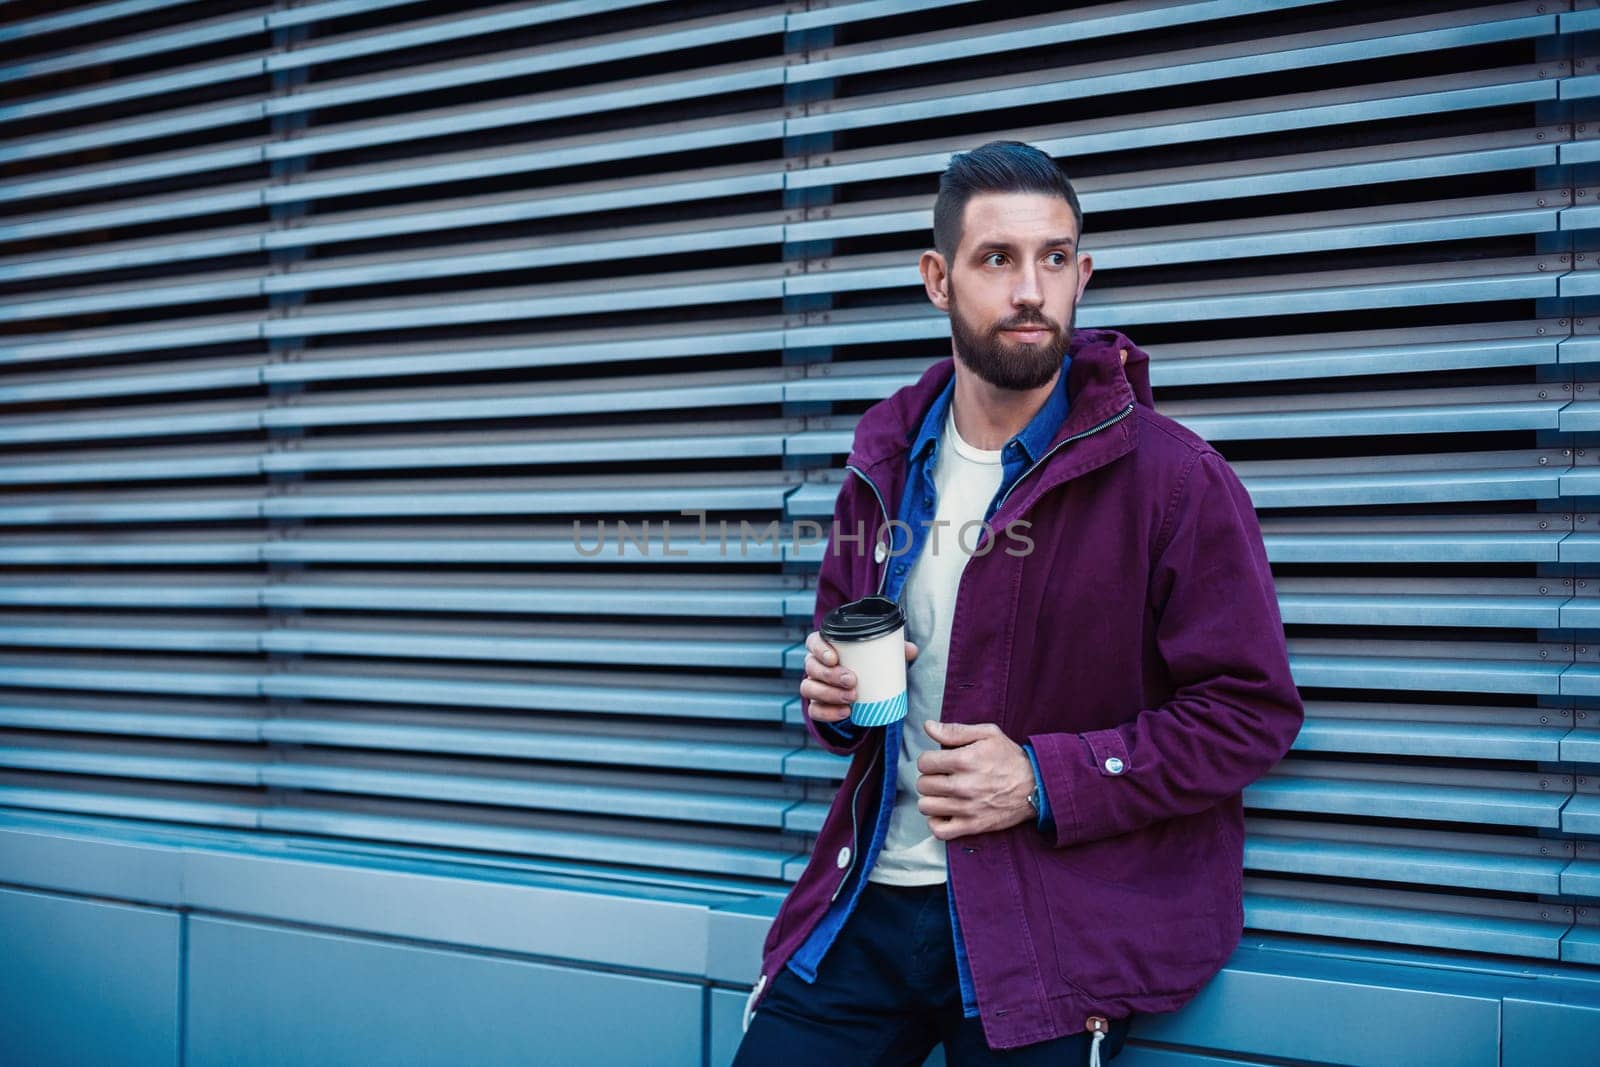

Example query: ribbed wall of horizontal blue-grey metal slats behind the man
[9,0,1600,963]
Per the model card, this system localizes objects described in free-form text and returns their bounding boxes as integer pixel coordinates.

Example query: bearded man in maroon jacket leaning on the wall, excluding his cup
[736,141,1302,1067]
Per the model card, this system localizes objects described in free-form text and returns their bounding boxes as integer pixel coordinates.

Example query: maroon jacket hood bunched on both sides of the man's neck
[848,330,1155,469]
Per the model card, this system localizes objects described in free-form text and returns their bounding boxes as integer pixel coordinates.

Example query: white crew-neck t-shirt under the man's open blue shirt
[867,403,1003,886]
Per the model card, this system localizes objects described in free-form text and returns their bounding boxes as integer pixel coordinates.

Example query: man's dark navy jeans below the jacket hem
[733,881,1128,1067]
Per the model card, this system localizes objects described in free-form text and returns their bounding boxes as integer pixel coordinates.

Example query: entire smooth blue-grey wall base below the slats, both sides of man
[0,811,1600,1067]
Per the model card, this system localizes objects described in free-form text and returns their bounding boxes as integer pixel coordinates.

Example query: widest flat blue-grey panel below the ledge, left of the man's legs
[184,918,702,1067]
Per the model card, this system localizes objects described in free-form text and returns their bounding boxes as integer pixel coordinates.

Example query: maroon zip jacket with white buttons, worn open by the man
[754,330,1304,1048]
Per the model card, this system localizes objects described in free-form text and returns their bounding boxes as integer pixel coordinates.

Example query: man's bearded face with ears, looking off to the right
[923,194,1093,390]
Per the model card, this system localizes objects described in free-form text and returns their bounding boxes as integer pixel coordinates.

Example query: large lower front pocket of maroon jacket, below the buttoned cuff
[1029,808,1238,998]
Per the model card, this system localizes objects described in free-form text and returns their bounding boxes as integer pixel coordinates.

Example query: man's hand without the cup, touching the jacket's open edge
[917,720,1035,841]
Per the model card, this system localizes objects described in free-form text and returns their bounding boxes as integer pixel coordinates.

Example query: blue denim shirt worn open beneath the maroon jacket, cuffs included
[789,357,1072,1017]
